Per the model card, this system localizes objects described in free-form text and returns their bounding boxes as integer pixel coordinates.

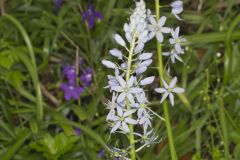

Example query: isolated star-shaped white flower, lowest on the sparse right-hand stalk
[155,77,184,106]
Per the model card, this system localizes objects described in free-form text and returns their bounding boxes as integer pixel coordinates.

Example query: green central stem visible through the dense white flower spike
[126,34,136,160]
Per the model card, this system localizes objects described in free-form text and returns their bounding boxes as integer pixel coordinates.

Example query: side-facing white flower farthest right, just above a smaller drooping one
[169,27,186,53]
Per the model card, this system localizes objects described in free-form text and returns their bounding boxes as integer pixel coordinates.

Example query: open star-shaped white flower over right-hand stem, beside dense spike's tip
[148,16,171,43]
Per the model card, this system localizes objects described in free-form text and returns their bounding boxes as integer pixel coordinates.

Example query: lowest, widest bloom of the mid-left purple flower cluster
[61,83,84,100]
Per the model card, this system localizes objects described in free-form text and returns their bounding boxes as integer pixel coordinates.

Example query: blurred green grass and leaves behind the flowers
[0,0,240,160]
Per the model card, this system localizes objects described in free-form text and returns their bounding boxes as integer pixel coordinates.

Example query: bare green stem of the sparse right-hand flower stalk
[155,0,177,160]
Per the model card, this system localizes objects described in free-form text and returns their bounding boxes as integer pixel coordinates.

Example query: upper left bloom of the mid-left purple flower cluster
[63,66,77,84]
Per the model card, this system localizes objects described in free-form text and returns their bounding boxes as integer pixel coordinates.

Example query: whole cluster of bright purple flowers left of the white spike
[61,65,92,100]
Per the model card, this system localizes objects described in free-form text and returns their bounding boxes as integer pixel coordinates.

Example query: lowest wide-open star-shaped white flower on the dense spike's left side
[111,107,138,133]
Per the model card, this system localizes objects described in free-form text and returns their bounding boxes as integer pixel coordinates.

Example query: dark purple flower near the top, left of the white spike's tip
[83,5,103,28]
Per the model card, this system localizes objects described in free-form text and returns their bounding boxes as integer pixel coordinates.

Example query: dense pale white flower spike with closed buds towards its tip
[102,0,158,158]
